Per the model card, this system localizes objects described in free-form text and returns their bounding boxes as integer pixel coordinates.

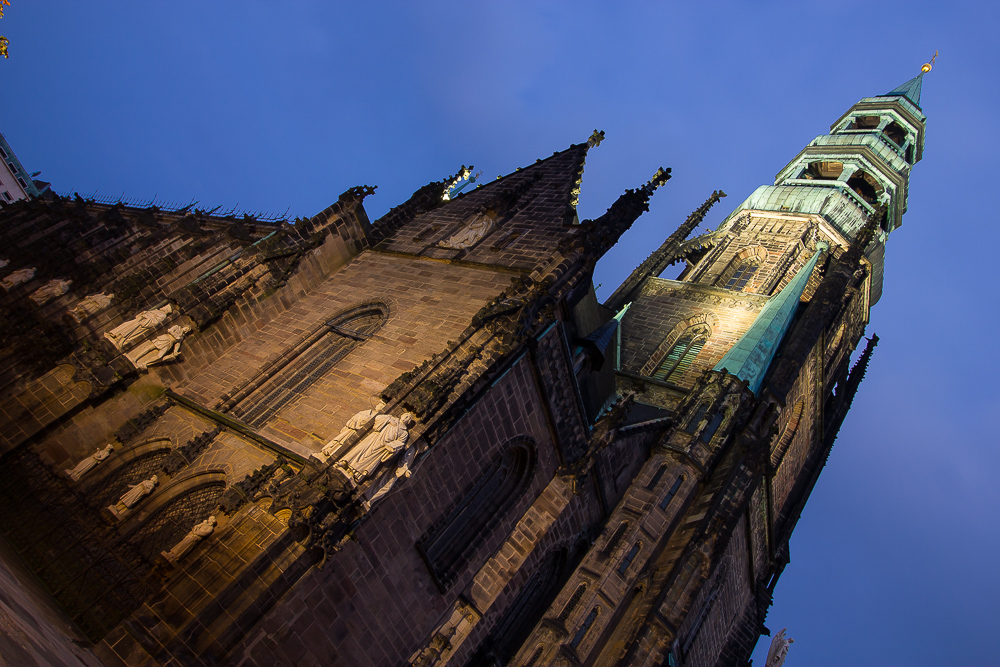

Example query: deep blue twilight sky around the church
[0,0,1000,667]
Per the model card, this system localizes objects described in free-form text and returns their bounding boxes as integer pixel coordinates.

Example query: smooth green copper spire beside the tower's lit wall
[713,247,829,394]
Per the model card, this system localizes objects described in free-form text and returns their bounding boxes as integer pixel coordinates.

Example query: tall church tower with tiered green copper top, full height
[513,65,930,667]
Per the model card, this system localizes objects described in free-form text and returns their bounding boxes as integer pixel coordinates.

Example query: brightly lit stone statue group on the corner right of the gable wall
[323,401,416,509]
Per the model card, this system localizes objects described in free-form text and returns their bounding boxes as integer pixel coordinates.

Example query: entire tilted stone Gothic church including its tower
[0,69,925,667]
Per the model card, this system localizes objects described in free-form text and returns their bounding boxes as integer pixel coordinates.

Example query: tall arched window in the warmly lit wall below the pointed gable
[234,304,389,428]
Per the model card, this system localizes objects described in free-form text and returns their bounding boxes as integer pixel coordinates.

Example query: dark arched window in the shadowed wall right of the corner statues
[417,438,535,591]
